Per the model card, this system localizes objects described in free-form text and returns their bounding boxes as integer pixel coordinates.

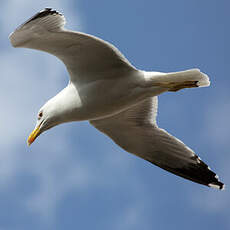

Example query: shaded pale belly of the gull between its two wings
[74,77,147,120]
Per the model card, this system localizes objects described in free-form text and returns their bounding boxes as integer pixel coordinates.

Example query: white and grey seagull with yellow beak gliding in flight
[9,8,224,190]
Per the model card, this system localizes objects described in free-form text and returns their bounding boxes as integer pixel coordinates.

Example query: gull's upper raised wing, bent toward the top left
[9,8,136,83]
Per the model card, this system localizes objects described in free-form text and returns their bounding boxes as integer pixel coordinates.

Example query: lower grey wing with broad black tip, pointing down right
[90,97,224,189]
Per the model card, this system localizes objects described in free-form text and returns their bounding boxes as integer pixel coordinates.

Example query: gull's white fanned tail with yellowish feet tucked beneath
[152,69,210,91]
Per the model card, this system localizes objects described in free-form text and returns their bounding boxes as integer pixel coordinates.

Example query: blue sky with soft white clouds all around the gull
[0,0,230,230]
